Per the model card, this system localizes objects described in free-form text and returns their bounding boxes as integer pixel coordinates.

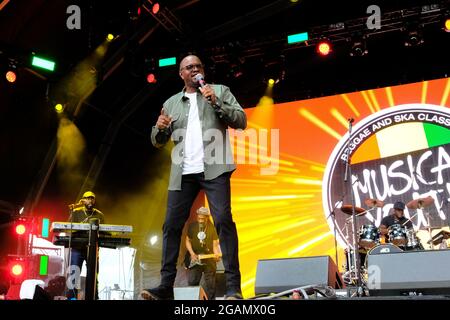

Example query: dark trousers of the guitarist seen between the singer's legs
[188,259,217,300]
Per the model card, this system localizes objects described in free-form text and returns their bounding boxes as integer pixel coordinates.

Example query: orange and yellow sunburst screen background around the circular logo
[231,78,450,297]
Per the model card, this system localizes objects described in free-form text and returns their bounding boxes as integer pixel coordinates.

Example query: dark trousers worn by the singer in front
[161,172,241,294]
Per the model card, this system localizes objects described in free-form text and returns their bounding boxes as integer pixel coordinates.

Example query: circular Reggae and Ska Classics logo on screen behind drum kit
[322,104,450,247]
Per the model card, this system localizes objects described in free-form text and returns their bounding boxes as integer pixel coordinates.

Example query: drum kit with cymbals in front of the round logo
[341,197,433,284]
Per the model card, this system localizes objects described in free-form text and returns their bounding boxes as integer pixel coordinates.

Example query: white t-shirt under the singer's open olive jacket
[183,92,205,174]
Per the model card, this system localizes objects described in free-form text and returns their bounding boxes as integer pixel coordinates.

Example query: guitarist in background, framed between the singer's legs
[185,207,221,300]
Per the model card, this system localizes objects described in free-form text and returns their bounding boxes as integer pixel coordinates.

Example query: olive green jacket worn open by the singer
[151,84,247,190]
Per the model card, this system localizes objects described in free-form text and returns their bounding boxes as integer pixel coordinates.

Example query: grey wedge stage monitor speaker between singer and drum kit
[255,256,343,295]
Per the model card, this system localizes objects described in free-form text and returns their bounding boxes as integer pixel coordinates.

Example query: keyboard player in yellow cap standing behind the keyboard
[67,191,105,300]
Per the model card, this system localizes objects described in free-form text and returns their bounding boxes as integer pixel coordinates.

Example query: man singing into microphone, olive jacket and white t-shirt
[141,55,247,299]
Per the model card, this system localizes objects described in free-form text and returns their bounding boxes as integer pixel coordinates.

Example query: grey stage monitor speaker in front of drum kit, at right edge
[367,250,450,296]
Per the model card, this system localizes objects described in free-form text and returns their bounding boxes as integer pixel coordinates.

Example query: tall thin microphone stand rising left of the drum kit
[344,118,362,296]
